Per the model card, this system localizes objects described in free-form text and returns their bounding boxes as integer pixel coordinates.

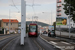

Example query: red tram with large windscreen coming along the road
[28,23,38,37]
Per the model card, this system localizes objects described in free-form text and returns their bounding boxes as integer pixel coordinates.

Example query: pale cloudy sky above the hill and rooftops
[0,0,56,24]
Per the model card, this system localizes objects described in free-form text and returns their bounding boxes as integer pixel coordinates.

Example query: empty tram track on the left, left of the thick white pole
[0,35,19,50]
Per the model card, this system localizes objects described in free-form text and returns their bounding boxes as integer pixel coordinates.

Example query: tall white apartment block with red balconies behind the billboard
[56,0,75,28]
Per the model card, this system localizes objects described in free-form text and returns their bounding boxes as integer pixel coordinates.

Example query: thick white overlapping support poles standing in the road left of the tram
[21,0,26,45]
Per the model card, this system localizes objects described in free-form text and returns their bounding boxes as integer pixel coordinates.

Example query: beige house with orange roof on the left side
[0,19,18,30]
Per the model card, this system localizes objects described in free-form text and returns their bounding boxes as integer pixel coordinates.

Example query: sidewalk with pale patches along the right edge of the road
[40,35,75,50]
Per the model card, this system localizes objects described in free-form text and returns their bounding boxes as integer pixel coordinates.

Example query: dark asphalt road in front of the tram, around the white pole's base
[0,36,58,50]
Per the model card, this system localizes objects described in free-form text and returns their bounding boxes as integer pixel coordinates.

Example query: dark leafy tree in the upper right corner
[63,0,75,21]
